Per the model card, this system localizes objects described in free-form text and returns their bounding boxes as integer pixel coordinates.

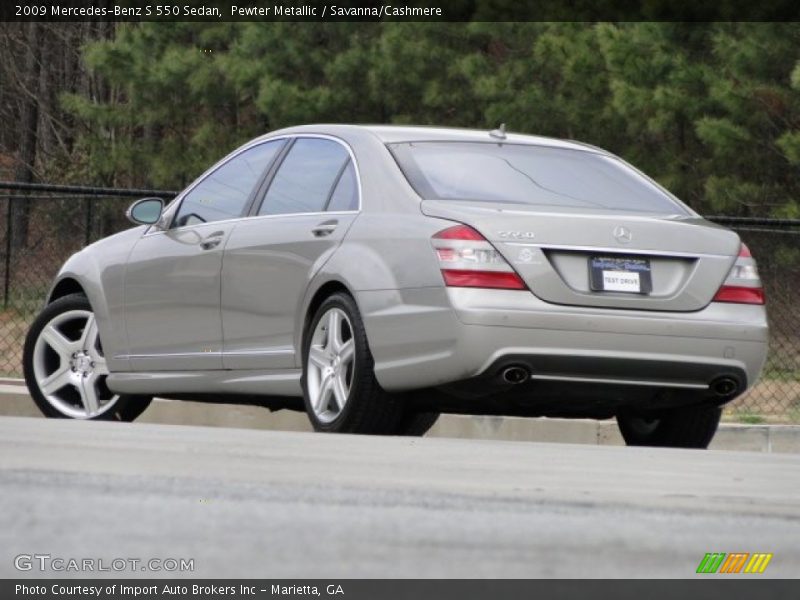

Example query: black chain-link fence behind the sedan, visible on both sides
[0,182,800,423]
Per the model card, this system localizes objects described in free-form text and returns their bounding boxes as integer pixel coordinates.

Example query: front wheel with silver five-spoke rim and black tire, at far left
[22,294,151,421]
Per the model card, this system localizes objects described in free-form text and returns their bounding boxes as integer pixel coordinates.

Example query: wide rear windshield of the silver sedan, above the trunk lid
[389,142,688,215]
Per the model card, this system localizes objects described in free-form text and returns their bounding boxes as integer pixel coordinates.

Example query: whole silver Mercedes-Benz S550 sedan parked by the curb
[24,125,767,447]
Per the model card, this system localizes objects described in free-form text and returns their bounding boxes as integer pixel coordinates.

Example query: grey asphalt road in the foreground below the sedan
[0,417,800,578]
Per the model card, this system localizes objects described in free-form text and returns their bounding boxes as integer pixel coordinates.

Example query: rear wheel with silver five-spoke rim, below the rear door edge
[302,293,403,435]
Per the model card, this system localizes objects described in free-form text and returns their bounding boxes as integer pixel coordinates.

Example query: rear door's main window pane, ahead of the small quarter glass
[258,138,350,215]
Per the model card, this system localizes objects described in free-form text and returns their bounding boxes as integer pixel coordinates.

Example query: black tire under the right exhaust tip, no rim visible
[617,406,722,448]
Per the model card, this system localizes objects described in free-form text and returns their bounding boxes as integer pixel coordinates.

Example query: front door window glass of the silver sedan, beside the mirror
[174,140,285,227]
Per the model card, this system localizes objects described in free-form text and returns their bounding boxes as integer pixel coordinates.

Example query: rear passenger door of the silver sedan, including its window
[222,137,360,369]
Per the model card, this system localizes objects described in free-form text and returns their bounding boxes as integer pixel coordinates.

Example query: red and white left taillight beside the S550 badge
[431,225,526,290]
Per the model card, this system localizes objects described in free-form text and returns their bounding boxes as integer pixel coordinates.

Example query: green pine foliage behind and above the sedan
[62,22,800,217]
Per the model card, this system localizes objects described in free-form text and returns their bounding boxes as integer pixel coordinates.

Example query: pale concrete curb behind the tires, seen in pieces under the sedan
[0,379,800,454]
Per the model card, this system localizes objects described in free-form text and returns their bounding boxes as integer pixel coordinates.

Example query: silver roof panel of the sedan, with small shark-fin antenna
[266,124,606,153]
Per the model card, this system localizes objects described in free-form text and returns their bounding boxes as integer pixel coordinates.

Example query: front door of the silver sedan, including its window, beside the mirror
[125,141,284,371]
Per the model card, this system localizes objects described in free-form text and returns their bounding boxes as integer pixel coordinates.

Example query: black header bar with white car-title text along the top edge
[0,0,800,23]
